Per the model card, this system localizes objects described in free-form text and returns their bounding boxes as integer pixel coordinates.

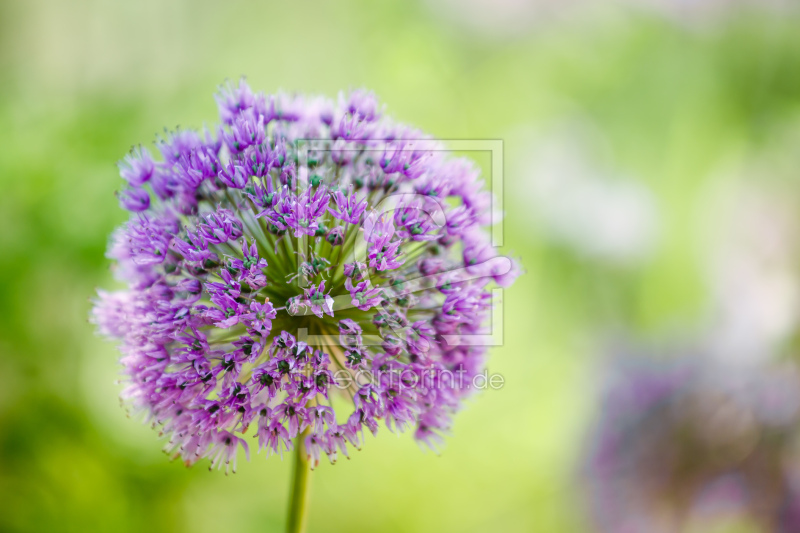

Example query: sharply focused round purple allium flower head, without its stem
[93,81,517,471]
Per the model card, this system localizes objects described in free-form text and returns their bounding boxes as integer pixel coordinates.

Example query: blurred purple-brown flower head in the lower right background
[585,358,800,533]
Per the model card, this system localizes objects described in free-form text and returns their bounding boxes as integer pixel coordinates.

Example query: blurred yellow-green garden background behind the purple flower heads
[0,0,800,533]
